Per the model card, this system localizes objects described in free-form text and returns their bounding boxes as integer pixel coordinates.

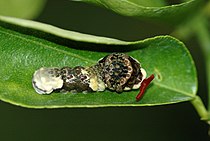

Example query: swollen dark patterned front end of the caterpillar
[98,53,146,93]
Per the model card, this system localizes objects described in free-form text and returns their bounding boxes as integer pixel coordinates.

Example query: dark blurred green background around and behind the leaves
[0,0,209,141]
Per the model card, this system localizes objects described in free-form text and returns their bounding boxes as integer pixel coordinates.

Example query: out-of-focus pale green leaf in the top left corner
[0,0,46,19]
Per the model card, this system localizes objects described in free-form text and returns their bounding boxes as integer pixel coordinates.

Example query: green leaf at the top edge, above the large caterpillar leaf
[79,0,203,23]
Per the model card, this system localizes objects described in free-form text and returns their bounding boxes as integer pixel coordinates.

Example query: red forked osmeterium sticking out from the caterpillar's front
[136,74,155,101]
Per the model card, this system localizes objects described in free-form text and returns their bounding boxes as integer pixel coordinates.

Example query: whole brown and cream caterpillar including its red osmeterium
[32,53,154,101]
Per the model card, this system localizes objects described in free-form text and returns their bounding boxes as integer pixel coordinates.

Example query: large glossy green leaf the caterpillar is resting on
[0,17,197,108]
